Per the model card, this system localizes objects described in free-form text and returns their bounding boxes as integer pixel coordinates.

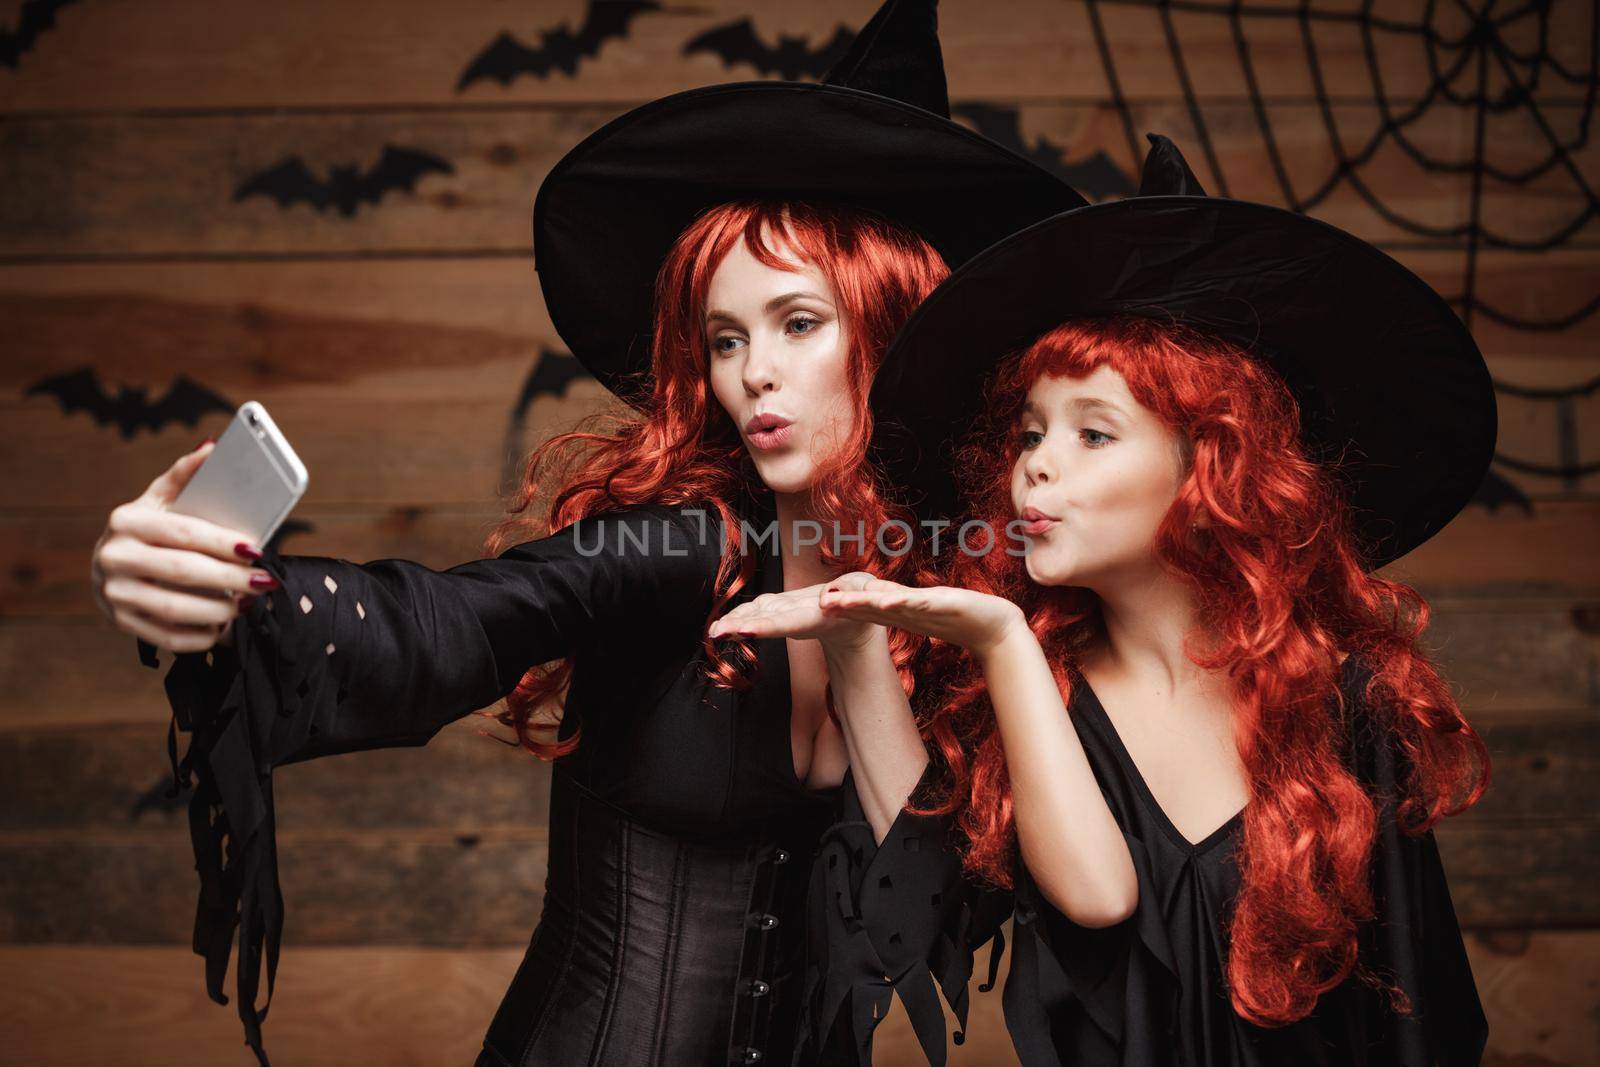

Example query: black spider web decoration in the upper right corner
[1083,0,1600,492]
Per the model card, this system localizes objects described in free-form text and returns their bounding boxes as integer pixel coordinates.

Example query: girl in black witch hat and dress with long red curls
[718,138,1494,1067]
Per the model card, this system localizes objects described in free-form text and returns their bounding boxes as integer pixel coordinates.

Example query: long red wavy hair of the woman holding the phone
[485,200,949,760]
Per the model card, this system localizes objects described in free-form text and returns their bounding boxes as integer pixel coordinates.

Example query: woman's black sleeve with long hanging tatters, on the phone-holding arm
[139,506,720,1065]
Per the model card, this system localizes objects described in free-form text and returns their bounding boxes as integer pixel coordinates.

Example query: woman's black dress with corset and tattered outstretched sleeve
[141,496,908,1067]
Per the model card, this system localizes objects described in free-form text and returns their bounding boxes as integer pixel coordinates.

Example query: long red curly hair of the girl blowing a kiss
[923,315,1490,1025]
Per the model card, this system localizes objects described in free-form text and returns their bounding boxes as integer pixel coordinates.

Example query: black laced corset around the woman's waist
[477,768,832,1067]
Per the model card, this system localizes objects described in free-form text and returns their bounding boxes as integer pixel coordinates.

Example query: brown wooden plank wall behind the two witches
[0,0,1600,1067]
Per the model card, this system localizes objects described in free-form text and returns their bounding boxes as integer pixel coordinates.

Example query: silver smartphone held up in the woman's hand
[166,400,310,547]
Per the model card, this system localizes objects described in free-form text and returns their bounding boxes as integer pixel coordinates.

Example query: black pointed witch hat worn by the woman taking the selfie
[533,0,1085,398]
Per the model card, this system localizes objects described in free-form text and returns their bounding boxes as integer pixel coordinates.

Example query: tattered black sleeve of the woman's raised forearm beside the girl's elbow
[794,760,1011,1067]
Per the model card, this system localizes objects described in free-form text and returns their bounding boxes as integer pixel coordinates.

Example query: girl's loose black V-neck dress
[832,657,1488,1067]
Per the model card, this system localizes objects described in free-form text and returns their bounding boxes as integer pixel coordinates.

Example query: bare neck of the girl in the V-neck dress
[1086,568,1214,694]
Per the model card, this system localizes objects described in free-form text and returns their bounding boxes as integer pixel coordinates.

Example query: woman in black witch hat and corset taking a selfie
[94,0,1082,1067]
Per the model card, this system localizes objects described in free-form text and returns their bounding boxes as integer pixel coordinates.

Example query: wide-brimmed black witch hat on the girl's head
[872,134,1498,566]
